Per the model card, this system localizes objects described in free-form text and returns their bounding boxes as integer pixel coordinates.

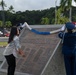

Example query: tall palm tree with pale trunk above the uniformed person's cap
[60,0,76,22]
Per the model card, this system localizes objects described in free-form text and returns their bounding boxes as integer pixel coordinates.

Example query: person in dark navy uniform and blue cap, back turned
[58,22,76,75]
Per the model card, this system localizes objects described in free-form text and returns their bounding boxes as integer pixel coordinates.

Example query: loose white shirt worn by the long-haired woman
[3,36,21,57]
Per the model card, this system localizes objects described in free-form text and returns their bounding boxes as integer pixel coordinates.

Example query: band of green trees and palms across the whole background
[0,0,76,27]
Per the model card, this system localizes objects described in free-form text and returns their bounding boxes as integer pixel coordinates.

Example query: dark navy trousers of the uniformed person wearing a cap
[64,55,76,75]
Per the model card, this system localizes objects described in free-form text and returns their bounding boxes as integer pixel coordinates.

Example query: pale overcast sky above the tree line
[0,0,76,11]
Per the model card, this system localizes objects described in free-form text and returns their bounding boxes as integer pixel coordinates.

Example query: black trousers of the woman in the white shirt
[5,54,16,75]
